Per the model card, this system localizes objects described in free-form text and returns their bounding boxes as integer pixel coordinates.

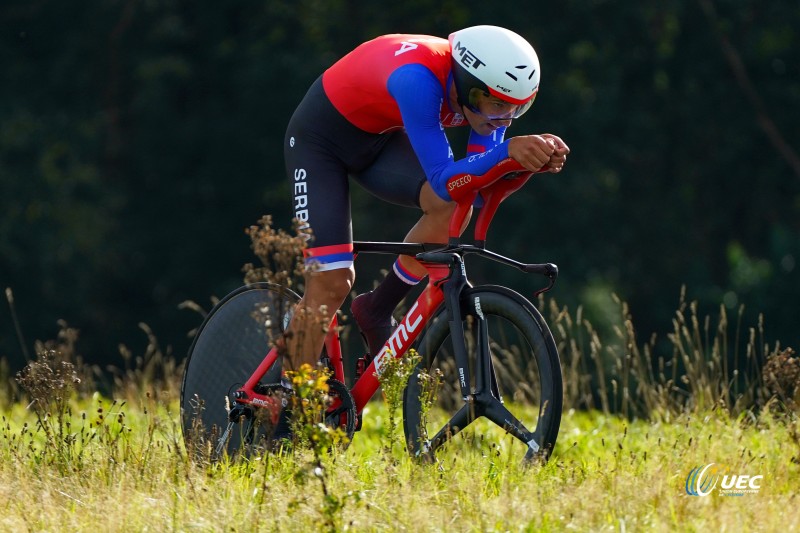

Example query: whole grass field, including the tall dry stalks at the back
[0,264,800,532]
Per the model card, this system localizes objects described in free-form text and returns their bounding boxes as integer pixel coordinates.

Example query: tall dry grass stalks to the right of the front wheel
[542,289,800,419]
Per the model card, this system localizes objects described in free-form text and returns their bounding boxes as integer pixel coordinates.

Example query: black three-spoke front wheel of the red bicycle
[403,285,563,463]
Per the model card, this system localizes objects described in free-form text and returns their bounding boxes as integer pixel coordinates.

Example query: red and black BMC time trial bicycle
[181,159,563,462]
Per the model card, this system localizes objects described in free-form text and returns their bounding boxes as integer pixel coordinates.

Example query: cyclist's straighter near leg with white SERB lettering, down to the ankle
[284,77,391,365]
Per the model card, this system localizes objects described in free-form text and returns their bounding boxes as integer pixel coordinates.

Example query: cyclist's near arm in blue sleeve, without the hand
[387,64,508,201]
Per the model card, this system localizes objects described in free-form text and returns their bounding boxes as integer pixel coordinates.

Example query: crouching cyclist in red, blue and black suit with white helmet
[284,26,569,374]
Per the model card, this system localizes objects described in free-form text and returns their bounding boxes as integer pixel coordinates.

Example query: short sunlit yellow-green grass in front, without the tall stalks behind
[0,370,800,531]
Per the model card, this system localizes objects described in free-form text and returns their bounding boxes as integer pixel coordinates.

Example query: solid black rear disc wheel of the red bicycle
[180,282,300,455]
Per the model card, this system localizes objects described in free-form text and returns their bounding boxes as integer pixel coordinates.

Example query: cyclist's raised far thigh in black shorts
[353,131,427,207]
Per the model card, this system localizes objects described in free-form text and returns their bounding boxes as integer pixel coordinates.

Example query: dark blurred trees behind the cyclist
[0,0,800,374]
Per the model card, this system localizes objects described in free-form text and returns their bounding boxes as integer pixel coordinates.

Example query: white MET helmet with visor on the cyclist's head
[449,26,540,118]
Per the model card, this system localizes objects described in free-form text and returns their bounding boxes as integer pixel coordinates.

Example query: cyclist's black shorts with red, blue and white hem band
[284,77,426,270]
